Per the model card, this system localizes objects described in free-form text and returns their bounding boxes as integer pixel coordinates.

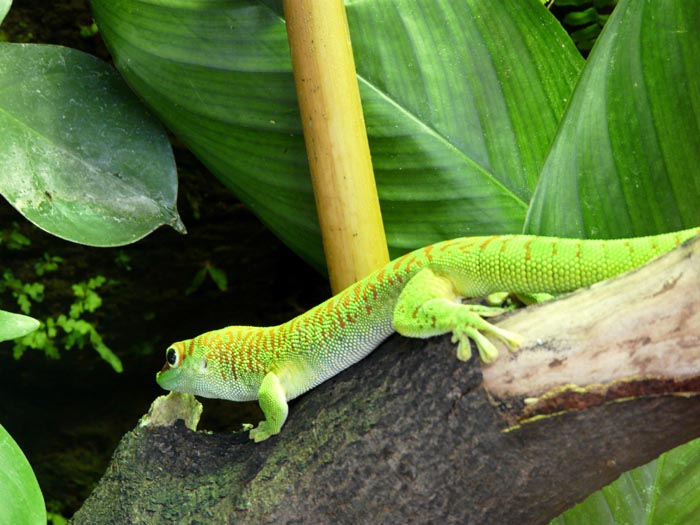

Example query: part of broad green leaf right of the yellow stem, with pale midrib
[348,1,582,252]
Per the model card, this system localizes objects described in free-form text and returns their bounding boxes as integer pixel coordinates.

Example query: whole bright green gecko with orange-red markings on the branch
[156,228,700,441]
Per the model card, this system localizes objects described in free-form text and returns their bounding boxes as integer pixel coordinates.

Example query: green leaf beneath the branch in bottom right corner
[552,439,700,525]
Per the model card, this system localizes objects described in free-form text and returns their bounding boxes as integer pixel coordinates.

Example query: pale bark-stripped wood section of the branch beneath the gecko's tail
[484,235,700,423]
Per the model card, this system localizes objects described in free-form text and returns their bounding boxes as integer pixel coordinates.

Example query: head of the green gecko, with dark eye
[156,341,212,397]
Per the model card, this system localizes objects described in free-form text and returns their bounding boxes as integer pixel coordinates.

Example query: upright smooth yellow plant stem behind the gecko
[283,0,389,293]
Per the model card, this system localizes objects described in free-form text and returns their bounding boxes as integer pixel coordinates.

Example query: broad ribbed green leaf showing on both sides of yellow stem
[92,0,582,266]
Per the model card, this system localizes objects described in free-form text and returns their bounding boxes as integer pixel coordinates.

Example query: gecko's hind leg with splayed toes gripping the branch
[393,268,521,363]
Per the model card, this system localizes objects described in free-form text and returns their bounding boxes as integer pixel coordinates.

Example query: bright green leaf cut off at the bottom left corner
[0,425,46,525]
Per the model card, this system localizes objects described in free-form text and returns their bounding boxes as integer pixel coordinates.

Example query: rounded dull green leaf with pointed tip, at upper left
[0,43,182,246]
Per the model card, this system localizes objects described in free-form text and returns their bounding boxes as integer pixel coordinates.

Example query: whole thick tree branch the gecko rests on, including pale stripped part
[72,238,700,524]
